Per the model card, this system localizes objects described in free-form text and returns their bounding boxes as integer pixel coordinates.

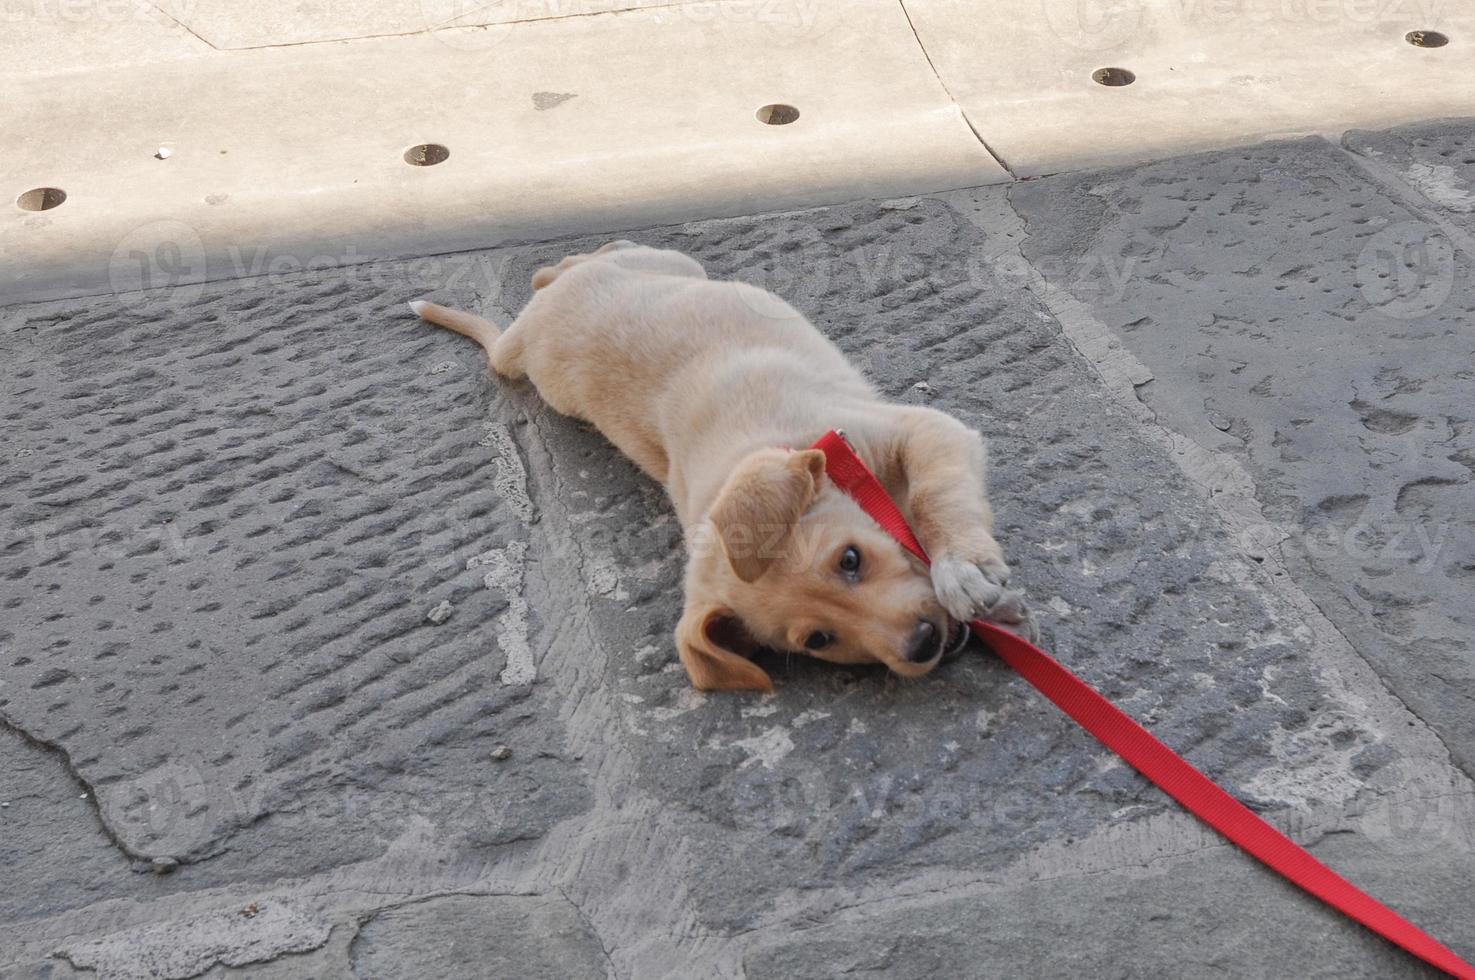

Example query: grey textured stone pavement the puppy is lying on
[0,123,1475,980]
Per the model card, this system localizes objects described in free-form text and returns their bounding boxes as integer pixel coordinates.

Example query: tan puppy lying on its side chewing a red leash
[410,242,1025,691]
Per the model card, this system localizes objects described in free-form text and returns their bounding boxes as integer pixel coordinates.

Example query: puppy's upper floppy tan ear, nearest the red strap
[707,449,825,582]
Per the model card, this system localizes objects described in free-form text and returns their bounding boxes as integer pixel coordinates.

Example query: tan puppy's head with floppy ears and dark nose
[676,449,966,691]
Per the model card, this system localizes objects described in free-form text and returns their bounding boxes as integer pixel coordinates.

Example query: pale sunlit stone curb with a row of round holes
[11,0,1475,301]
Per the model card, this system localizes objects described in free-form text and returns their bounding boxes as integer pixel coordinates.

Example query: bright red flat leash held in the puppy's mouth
[811,431,1475,980]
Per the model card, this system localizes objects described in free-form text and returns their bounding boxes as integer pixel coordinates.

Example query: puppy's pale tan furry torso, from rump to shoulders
[519,271,875,481]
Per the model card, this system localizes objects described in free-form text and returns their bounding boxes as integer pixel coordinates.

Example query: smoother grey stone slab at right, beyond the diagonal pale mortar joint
[1012,128,1475,772]
